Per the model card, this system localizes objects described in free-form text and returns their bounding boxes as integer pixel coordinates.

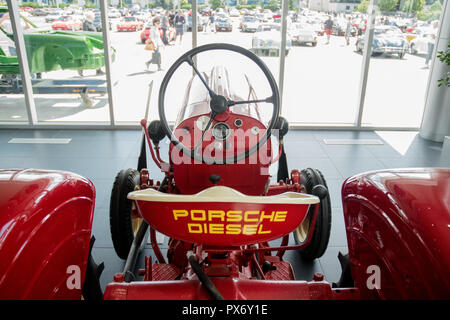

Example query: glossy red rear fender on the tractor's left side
[0,169,95,299]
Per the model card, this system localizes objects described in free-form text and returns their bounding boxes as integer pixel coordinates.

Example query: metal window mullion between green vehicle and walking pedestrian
[99,0,116,126]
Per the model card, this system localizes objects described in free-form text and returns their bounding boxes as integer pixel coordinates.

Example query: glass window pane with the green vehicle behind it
[7,8,110,124]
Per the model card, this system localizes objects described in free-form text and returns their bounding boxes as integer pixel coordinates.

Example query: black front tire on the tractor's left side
[109,169,140,259]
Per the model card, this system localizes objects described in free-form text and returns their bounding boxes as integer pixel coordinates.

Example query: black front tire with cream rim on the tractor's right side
[293,168,331,261]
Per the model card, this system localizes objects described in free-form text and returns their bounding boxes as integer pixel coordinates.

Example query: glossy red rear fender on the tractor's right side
[342,168,450,299]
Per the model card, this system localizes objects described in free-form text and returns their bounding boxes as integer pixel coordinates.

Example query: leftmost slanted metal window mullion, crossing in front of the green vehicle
[7,0,37,125]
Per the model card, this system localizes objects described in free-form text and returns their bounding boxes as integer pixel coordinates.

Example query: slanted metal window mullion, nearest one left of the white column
[355,0,378,128]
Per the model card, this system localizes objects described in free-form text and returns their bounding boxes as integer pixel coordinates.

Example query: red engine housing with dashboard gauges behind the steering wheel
[169,112,272,195]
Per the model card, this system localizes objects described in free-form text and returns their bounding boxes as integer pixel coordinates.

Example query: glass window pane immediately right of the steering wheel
[282,9,365,125]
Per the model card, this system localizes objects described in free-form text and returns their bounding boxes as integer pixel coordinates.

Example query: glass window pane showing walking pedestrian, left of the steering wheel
[108,6,192,124]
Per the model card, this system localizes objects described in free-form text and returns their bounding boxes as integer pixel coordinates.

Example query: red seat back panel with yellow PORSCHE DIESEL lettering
[137,200,309,246]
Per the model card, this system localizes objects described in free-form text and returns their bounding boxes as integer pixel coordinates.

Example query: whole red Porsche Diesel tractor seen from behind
[0,44,450,300]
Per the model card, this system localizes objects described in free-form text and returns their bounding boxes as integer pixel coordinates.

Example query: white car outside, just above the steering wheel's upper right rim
[250,23,292,57]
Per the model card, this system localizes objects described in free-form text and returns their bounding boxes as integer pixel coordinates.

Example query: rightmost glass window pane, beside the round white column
[362,1,440,127]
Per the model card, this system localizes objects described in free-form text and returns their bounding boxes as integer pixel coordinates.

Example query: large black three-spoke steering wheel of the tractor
[158,43,280,163]
